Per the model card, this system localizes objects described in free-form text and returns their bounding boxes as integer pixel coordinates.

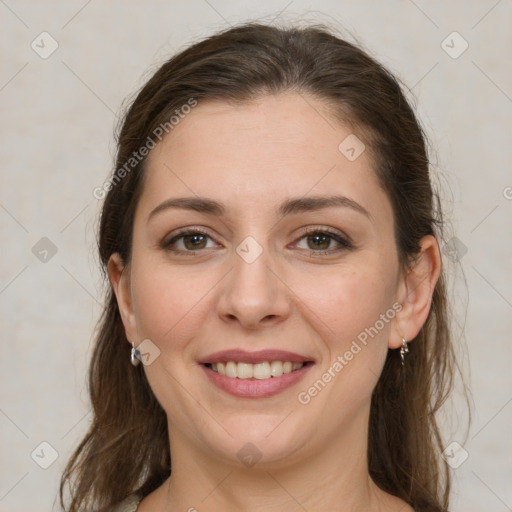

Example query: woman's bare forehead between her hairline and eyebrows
[141,92,390,224]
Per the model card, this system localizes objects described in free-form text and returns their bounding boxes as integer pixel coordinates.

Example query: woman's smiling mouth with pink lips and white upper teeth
[198,350,315,398]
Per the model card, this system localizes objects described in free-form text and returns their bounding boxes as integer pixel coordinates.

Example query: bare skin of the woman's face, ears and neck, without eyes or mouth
[108,93,441,512]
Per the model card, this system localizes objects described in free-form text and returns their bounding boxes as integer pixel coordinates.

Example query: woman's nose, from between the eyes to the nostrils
[217,241,290,330]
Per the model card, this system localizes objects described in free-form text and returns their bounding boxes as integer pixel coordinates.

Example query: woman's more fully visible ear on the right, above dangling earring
[388,235,442,348]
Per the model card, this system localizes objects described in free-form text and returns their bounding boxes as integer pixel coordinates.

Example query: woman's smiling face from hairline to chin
[112,93,403,464]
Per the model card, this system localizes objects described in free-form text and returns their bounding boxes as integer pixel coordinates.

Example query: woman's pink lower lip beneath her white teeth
[201,364,313,398]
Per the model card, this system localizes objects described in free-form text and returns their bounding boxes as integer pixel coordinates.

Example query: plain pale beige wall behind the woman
[0,0,512,512]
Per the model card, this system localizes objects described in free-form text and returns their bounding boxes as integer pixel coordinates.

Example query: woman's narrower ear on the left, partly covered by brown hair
[107,253,138,342]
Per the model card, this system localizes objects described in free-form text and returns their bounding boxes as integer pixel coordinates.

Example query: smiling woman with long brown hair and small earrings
[60,23,453,512]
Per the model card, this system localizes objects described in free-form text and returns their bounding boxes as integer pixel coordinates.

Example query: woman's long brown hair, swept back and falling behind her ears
[60,23,460,512]
